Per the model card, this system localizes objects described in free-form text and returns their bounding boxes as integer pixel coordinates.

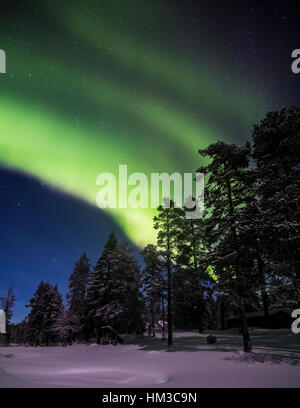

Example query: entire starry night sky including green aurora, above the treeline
[0,0,300,321]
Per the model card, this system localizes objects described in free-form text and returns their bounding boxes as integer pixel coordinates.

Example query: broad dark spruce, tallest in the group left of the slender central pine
[87,234,142,343]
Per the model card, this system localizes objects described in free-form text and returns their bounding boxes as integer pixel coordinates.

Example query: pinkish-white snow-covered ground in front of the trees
[0,329,300,387]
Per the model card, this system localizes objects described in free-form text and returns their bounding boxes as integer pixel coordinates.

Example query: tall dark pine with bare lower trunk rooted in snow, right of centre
[198,142,253,352]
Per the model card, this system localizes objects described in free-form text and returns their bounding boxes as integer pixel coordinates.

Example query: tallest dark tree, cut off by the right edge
[253,106,300,309]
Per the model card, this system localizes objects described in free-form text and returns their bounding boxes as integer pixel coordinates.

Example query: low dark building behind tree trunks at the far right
[225,310,293,329]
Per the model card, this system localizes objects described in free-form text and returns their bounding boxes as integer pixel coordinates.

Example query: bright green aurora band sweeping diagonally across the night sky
[0,1,266,246]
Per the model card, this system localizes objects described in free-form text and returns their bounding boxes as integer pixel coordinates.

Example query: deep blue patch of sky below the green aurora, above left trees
[0,168,137,321]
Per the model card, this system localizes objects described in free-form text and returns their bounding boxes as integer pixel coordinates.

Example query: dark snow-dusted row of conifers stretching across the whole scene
[0,106,300,352]
